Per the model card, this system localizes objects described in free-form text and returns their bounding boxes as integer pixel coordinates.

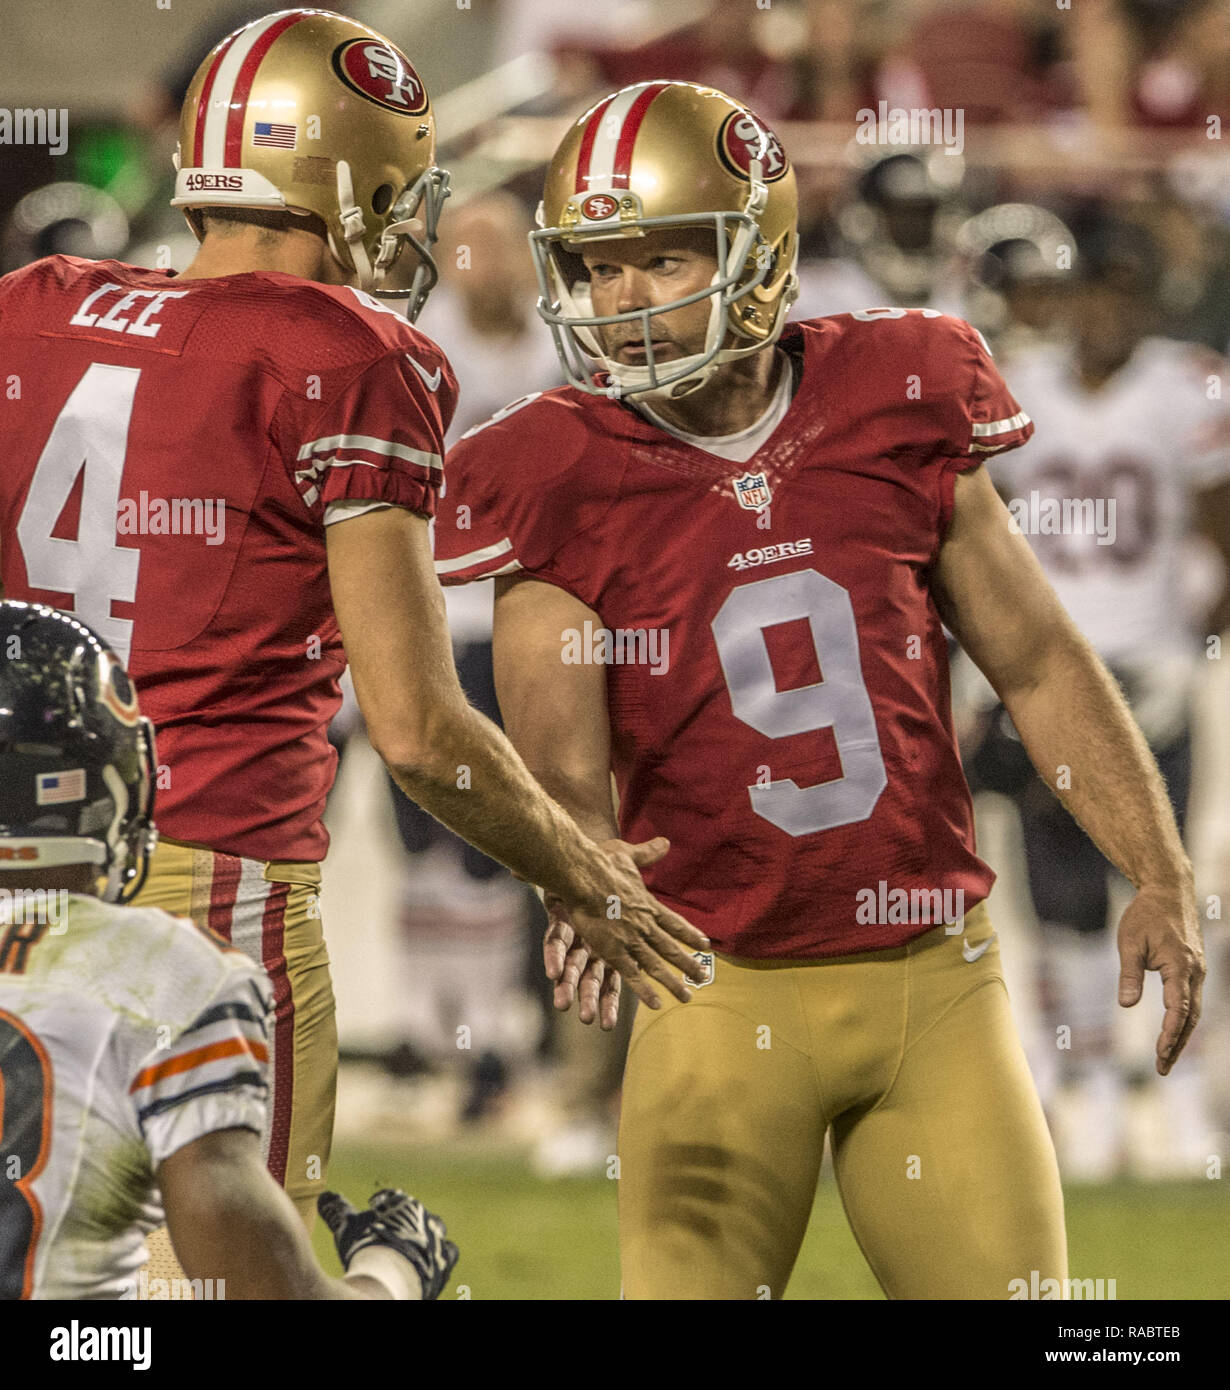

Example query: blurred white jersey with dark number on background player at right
[990,338,1230,667]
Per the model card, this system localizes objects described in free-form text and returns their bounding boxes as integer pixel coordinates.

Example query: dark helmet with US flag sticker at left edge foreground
[0,599,157,902]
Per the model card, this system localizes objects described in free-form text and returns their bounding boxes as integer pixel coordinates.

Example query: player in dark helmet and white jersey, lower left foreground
[0,600,457,1300]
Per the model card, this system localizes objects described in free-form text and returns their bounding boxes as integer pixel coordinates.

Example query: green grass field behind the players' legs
[315,1144,1230,1300]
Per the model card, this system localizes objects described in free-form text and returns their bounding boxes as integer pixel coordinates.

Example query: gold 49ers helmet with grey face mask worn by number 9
[530,82,798,396]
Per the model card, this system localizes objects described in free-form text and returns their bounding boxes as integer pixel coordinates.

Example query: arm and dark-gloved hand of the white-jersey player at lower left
[157,1129,456,1301]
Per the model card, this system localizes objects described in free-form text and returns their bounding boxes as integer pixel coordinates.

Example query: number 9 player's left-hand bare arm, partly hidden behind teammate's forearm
[493,575,653,1030]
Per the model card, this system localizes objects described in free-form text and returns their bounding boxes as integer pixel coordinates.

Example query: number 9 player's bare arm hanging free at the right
[933,468,1205,1076]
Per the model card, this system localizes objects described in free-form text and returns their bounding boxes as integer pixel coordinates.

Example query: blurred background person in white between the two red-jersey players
[378,192,560,1120]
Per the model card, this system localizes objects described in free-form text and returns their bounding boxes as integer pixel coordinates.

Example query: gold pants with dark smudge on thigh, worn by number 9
[620,904,1067,1298]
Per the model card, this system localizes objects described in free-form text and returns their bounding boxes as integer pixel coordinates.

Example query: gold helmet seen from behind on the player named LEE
[171,10,449,321]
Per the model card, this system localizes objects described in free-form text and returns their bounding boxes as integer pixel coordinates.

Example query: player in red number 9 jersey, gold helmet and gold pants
[436,82,1204,1298]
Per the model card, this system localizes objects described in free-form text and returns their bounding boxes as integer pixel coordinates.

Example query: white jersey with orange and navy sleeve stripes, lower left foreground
[0,895,271,1300]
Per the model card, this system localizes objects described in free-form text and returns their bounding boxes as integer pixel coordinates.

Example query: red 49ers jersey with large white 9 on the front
[435,310,1033,958]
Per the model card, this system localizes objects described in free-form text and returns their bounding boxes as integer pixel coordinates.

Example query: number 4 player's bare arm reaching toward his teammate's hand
[327,509,705,1008]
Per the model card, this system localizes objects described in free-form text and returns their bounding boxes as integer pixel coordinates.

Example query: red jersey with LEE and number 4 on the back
[0,256,456,860]
